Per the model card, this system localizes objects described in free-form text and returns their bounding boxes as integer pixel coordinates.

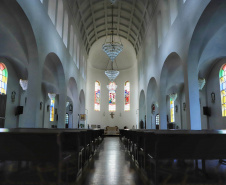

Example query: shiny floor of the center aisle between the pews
[78,137,147,185]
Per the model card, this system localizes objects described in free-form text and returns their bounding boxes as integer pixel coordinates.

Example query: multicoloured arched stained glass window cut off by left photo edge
[0,63,8,94]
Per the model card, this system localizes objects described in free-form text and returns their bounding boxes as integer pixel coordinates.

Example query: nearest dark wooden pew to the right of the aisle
[145,130,226,184]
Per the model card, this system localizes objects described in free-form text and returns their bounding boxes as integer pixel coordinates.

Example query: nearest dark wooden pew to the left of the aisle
[0,129,70,184]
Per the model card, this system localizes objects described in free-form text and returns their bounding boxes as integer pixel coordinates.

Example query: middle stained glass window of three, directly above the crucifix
[108,82,117,112]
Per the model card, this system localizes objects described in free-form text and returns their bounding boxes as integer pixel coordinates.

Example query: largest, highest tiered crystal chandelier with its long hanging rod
[102,0,123,62]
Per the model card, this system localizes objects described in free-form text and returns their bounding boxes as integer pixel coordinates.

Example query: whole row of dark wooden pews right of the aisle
[123,130,226,184]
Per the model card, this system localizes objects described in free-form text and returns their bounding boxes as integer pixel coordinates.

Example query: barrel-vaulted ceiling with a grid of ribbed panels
[67,0,158,53]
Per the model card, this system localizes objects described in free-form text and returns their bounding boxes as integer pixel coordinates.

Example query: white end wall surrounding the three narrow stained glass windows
[86,65,138,128]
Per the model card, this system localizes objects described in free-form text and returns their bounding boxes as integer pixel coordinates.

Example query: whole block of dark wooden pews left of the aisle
[0,128,102,184]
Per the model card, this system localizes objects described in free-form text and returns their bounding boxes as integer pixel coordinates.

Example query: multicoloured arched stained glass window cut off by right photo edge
[219,64,226,117]
